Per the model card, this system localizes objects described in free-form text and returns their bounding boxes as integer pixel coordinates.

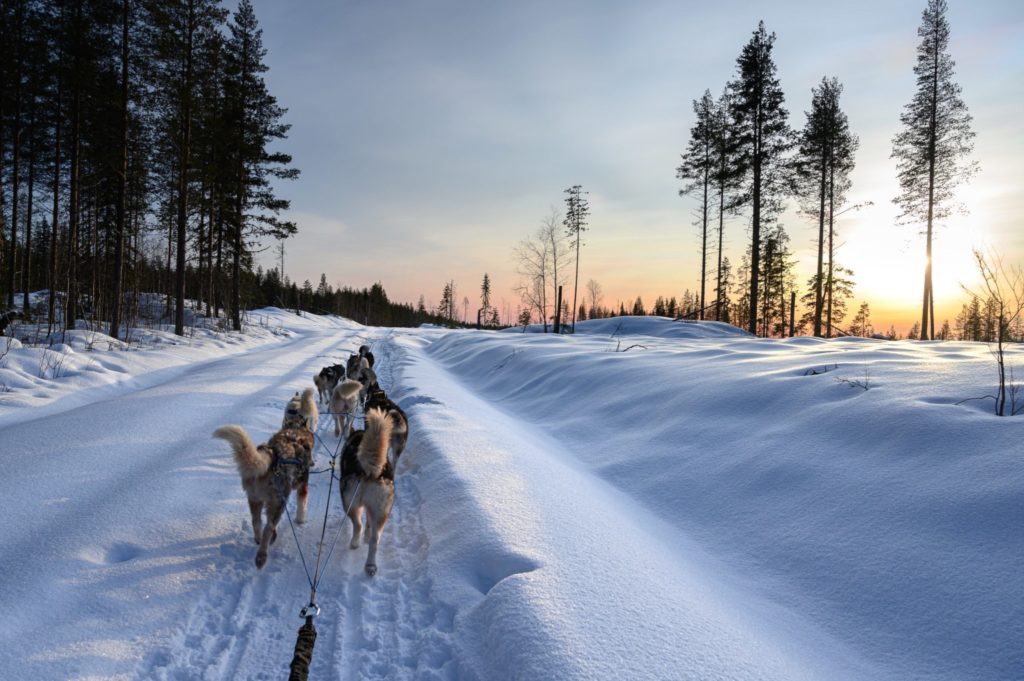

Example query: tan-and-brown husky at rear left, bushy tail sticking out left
[213,426,313,567]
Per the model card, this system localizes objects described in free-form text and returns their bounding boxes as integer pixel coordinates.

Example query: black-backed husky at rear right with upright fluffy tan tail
[339,409,394,577]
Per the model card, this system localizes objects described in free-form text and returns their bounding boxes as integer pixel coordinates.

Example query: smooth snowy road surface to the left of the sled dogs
[0,321,380,679]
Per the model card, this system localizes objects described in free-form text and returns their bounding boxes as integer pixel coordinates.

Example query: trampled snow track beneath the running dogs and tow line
[137,332,458,681]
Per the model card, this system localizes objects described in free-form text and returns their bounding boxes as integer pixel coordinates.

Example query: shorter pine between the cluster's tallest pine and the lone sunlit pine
[795,78,858,337]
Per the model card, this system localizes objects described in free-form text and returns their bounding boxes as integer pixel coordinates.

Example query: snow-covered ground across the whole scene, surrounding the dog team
[0,310,1024,681]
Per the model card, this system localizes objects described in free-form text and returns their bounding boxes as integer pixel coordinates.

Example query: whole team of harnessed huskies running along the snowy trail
[213,345,409,577]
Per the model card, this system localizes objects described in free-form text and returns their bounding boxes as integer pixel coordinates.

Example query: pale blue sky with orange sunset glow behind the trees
[247,0,1024,333]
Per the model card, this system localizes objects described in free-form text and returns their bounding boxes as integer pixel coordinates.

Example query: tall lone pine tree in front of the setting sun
[892,0,977,340]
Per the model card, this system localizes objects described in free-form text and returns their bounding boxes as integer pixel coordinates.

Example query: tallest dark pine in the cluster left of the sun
[730,22,793,334]
